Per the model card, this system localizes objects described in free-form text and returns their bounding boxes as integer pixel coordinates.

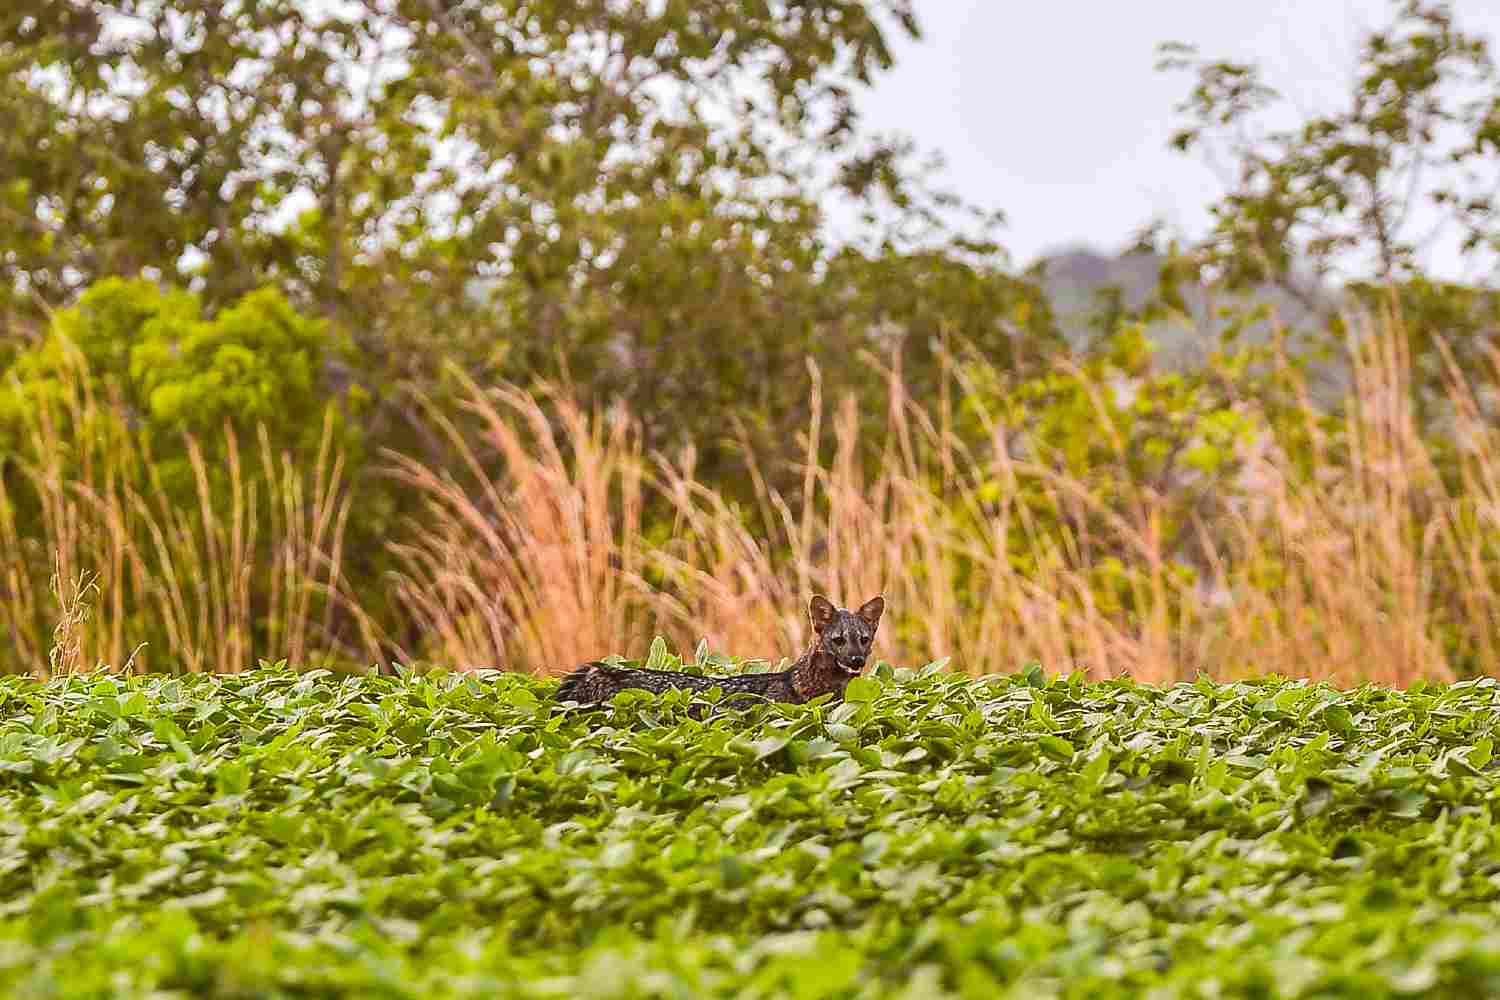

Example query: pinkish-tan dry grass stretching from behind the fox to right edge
[384,316,1500,685]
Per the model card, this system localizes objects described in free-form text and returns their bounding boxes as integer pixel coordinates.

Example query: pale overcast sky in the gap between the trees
[863,0,1500,276]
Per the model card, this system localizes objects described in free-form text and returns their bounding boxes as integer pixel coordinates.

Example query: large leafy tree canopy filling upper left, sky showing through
[0,0,1049,485]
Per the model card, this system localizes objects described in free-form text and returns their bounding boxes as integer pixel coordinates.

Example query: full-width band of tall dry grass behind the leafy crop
[0,308,1500,685]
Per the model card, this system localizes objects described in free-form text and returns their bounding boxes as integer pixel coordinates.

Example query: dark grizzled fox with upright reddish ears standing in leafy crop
[557,597,885,705]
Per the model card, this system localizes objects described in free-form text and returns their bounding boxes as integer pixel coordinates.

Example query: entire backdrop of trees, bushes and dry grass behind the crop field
[0,0,1500,682]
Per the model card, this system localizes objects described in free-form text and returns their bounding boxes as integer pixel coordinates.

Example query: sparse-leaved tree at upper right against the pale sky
[1163,0,1500,405]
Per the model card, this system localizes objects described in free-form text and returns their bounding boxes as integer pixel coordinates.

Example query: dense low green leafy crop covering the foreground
[0,658,1500,997]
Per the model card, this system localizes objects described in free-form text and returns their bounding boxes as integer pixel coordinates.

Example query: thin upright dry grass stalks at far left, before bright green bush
[0,350,354,676]
